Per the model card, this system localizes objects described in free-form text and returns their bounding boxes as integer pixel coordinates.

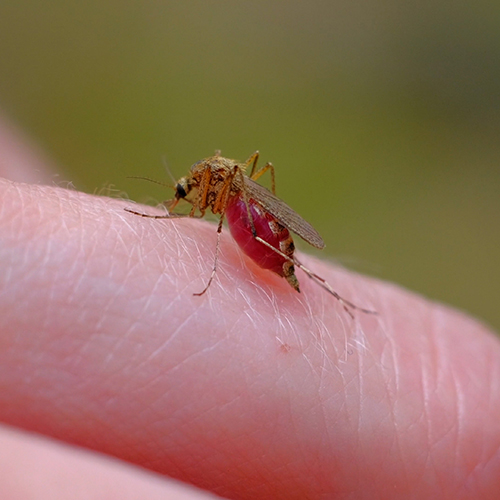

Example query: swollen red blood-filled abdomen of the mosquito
[225,196,290,276]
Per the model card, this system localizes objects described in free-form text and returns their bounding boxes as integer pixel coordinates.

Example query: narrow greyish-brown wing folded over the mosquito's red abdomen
[245,177,325,248]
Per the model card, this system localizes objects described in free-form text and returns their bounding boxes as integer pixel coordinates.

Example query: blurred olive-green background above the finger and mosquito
[0,0,500,328]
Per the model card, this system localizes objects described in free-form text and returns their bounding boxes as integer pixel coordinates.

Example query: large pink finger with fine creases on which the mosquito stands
[0,120,500,499]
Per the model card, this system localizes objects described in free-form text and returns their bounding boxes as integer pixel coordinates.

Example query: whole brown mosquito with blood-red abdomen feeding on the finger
[125,151,377,318]
